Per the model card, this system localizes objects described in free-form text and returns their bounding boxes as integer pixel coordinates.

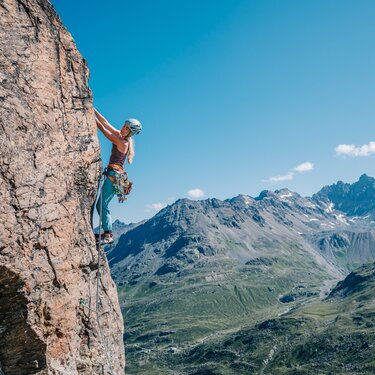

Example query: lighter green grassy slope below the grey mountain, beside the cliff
[119,242,336,375]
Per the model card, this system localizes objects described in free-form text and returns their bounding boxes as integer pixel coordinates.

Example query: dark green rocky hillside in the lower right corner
[170,264,375,375]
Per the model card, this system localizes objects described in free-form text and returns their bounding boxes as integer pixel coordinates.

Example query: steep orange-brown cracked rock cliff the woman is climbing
[0,0,125,375]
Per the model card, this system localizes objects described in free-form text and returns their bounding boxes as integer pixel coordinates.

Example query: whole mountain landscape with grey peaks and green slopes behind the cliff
[107,175,375,374]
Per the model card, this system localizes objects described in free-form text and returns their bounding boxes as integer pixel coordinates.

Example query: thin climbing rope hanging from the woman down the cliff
[79,171,115,375]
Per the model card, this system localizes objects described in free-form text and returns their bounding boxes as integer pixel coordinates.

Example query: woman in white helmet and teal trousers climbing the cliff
[94,109,142,244]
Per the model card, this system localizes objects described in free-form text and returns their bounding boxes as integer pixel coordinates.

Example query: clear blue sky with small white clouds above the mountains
[52,0,375,222]
